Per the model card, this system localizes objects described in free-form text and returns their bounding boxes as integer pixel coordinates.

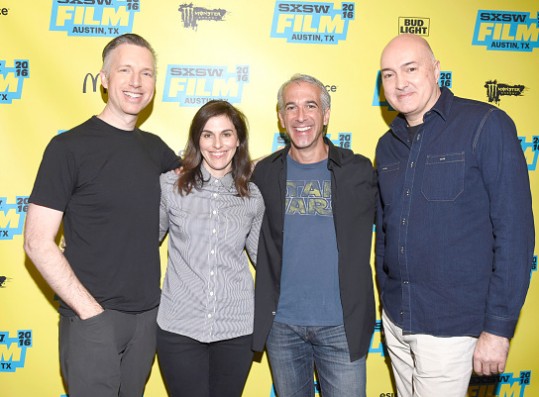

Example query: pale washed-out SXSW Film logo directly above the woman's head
[163,65,250,106]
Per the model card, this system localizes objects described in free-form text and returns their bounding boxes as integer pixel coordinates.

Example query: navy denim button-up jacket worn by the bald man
[376,88,535,338]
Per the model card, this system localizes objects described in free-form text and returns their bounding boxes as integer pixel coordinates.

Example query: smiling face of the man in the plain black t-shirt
[101,44,155,118]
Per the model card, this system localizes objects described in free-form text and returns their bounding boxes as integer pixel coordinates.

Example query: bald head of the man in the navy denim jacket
[381,37,440,125]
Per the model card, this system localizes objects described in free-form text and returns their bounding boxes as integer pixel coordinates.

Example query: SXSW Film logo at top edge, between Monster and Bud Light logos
[271,1,356,44]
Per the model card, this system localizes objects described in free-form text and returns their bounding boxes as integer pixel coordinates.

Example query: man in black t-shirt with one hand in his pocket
[24,34,179,397]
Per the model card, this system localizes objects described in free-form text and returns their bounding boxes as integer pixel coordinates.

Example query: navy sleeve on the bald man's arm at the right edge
[475,108,535,338]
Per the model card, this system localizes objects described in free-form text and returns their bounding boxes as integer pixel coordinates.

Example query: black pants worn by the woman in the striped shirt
[157,327,253,397]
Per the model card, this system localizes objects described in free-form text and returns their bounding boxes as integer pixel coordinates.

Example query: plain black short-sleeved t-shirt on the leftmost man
[30,116,179,315]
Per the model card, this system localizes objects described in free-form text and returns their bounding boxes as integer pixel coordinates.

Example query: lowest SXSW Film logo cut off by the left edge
[0,330,32,373]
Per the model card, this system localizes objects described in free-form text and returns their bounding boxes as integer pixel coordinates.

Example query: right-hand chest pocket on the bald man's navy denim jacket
[421,152,465,201]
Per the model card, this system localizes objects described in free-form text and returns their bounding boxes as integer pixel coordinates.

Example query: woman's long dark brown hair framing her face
[178,100,251,197]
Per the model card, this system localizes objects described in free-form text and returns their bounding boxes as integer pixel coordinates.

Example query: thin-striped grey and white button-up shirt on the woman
[157,167,264,343]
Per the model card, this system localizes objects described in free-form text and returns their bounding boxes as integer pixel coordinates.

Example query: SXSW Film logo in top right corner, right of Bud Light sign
[472,10,539,52]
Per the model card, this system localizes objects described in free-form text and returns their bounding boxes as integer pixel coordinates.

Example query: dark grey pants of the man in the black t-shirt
[60,308,157,397]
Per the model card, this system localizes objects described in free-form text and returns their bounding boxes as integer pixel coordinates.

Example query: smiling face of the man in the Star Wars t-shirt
[279,81,330,150]
